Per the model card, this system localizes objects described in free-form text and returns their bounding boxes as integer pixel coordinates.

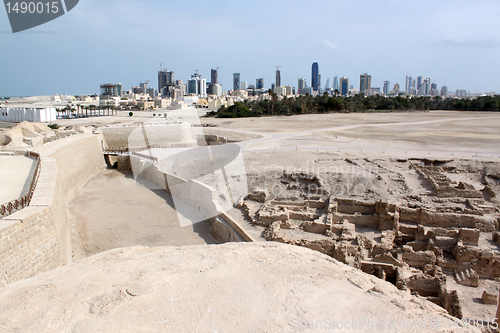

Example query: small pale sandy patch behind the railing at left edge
[0,156,35,204]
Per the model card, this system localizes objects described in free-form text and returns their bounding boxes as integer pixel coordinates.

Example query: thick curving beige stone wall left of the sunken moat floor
[0,135,105,286]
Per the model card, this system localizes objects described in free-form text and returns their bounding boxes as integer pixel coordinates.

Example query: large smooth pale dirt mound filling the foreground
[0,243,476,333]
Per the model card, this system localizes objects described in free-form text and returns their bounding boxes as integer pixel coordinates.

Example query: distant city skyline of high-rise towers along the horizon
[93,62,468,110]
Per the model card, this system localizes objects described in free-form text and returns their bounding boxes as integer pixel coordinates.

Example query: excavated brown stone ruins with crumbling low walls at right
[238,160,500,318]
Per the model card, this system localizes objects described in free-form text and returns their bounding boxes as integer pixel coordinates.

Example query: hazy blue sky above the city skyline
[0,0,500,96]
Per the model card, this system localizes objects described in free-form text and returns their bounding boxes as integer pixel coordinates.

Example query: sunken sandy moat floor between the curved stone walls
[68,170,218,259]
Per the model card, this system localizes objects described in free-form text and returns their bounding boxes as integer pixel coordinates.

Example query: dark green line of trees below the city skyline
[208,92,500,118]
